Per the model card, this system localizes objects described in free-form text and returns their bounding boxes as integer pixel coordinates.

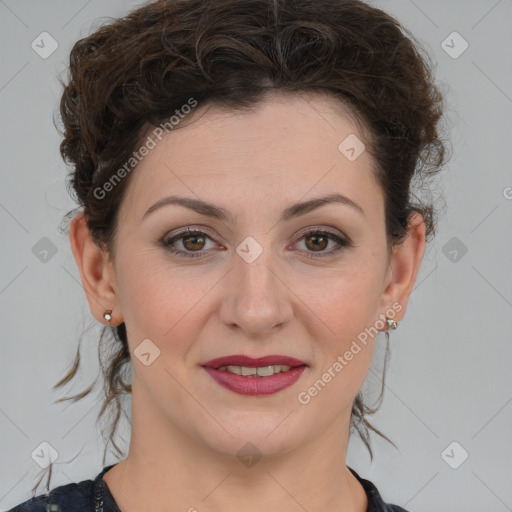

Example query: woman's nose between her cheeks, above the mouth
[220,246,293,338]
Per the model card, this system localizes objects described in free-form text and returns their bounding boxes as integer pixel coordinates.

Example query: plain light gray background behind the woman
[0,0,512,512]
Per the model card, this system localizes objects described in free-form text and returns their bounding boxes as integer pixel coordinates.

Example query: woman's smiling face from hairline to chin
[87,95,420,460]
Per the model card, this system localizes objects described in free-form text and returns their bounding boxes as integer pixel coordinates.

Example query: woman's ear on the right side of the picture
[381,211,426,322]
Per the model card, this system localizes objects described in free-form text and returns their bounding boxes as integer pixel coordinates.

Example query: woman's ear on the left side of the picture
[69,213,122,326]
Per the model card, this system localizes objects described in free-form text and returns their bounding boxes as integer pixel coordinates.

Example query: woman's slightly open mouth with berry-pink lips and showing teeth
[202,355,307,396]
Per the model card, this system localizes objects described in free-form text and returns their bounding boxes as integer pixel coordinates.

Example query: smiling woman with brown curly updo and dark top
[12,0,445,512]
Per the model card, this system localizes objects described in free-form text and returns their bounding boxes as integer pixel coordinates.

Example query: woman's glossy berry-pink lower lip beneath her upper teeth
[203,366,306,396]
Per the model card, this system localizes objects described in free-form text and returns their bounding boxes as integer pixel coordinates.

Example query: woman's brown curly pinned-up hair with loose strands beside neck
[36,0,447,496]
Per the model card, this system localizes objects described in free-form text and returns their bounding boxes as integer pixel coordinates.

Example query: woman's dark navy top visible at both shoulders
[7,464,407,512]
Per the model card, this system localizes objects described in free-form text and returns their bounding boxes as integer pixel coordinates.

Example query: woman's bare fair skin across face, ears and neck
[70,94,425,512]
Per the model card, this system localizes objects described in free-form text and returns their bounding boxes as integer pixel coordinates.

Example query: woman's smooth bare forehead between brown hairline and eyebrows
[116,94,382,224]
